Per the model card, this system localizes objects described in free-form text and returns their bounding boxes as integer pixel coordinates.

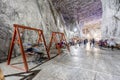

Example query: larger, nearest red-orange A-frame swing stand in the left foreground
[7,24,50,72]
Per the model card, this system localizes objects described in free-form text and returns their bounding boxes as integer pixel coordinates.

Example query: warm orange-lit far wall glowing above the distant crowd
[83,20,101,40]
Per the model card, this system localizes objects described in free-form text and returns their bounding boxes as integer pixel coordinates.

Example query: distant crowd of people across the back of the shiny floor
[69,38,120,50]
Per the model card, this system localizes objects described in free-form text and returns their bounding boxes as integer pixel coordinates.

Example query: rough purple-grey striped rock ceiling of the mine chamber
[52,0,102,22]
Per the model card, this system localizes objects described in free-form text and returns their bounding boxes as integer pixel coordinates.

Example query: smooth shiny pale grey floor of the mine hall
[0,45,120,80]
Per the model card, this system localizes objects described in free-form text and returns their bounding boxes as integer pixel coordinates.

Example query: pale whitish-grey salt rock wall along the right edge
[102,0,120,43]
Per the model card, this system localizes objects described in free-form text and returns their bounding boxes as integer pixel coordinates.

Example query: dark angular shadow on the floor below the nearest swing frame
[5,70,41,80]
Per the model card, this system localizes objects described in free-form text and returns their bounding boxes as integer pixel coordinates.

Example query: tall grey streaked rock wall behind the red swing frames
[0,0,64,61]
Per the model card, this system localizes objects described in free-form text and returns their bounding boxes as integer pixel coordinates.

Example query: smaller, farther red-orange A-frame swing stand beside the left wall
[48,32,70,55]
